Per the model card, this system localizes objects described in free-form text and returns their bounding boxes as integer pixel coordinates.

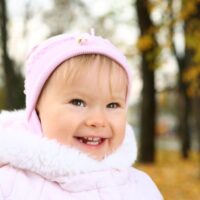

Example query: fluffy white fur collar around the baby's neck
[0,110,137,179]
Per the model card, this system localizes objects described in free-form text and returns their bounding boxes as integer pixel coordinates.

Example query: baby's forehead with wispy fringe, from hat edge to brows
[44,54,128,93]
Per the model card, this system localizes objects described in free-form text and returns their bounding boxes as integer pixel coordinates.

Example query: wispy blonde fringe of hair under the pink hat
[42,54,128,99]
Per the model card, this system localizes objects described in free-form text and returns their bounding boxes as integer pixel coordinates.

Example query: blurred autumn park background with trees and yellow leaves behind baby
[0,0,200,200]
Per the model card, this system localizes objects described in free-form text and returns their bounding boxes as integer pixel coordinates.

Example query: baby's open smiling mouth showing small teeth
[75,136,106,146]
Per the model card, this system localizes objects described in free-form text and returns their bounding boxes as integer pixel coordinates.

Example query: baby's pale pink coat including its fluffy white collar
[0,111,163,200]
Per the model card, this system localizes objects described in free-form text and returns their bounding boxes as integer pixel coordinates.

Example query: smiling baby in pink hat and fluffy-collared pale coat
[0,34,162,200]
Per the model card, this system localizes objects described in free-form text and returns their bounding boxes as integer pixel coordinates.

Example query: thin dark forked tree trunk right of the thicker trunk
[169,0,192,158]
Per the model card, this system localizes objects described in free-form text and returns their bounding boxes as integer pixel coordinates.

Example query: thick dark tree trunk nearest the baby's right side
[136,0,156,162]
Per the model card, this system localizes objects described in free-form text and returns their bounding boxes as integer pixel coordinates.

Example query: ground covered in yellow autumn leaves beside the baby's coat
[136,151,200,200]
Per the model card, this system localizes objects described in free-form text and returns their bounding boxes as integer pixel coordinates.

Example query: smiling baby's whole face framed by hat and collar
[37,56,127,160]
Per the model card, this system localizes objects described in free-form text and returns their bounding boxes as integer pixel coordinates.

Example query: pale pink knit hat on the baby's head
[25,33,131,135]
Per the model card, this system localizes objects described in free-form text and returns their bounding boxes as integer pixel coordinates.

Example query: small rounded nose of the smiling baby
[86,108,106,128]
